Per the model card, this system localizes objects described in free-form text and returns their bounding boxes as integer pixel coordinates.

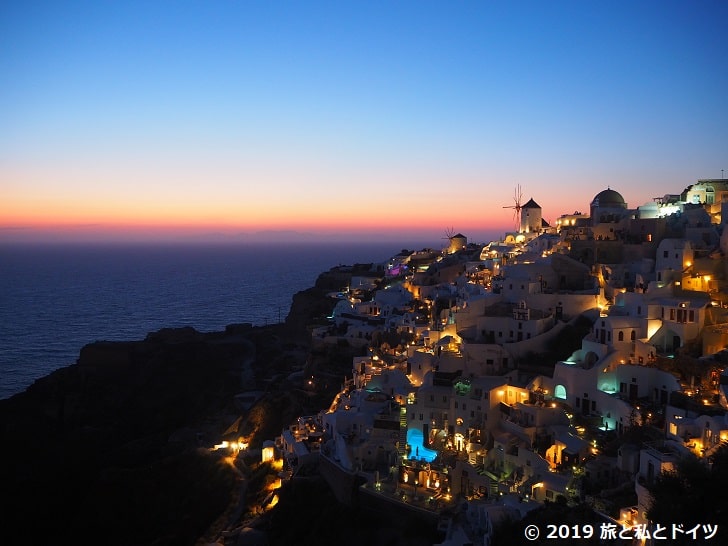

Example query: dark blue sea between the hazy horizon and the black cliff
[0,243,400,398]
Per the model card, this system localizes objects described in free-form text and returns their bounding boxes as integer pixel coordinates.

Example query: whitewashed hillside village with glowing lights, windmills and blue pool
[263,180,728,544]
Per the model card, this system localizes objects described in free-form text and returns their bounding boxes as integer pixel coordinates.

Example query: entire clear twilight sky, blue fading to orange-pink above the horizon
[0,0,728,242]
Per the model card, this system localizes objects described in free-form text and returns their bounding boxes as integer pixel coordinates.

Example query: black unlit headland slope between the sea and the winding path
[0,328,264,544]
